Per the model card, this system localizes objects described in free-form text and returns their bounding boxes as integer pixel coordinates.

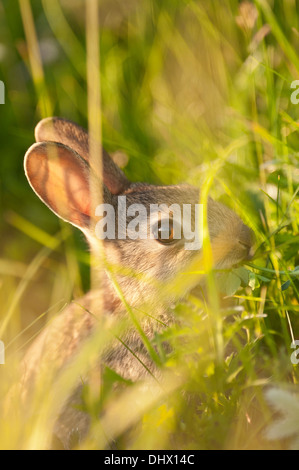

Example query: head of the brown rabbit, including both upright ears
[25,118,252,305]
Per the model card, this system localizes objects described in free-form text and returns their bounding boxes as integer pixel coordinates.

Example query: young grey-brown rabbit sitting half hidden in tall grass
[22,117,253,449]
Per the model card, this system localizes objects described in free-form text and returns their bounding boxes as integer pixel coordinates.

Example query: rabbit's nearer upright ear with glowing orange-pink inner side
[24,142,112,229]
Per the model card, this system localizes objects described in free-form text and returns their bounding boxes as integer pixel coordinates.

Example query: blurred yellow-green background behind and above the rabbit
[0,0,299,447]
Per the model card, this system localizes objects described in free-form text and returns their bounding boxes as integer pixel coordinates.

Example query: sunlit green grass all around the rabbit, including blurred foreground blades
[0,0,299,449]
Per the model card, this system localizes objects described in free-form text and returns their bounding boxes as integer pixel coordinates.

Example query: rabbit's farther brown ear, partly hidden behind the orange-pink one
[35,117,131,194]
